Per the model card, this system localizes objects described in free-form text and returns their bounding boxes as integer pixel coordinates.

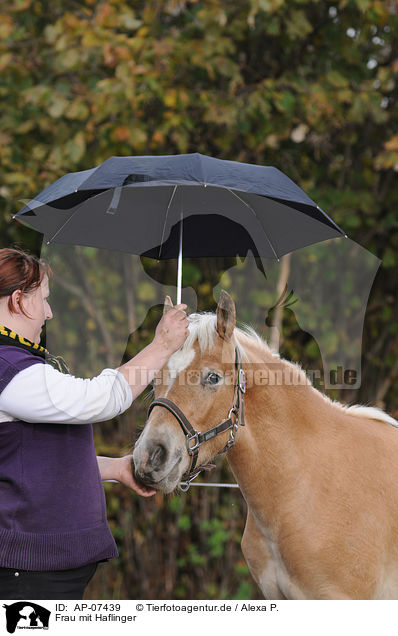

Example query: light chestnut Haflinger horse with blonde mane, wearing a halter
[133,292,398,599]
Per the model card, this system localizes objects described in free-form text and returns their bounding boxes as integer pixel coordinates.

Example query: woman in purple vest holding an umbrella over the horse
[0,249,188,599]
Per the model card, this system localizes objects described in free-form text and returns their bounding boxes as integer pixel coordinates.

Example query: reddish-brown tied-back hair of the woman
[0,248,52,317]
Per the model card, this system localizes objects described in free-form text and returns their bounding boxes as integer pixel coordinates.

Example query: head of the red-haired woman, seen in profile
[0,248,52,343]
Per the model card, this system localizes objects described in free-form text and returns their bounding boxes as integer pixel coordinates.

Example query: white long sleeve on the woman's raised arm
[0,363,133,424]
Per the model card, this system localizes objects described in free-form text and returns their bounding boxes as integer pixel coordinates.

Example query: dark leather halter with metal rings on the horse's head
[147,347,246,491]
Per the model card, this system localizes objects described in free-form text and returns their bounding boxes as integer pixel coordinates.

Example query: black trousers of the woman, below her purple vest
[0,563,97,601]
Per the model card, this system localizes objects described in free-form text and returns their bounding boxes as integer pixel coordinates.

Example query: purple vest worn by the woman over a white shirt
[0,346,118,571]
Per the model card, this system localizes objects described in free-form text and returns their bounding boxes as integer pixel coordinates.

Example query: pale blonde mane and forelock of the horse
[187,312,398,427]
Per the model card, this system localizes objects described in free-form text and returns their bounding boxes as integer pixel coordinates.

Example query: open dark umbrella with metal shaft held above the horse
[14,153,344,302]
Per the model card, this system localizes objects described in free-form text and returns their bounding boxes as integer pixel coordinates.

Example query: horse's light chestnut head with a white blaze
[133,291,243,493]
